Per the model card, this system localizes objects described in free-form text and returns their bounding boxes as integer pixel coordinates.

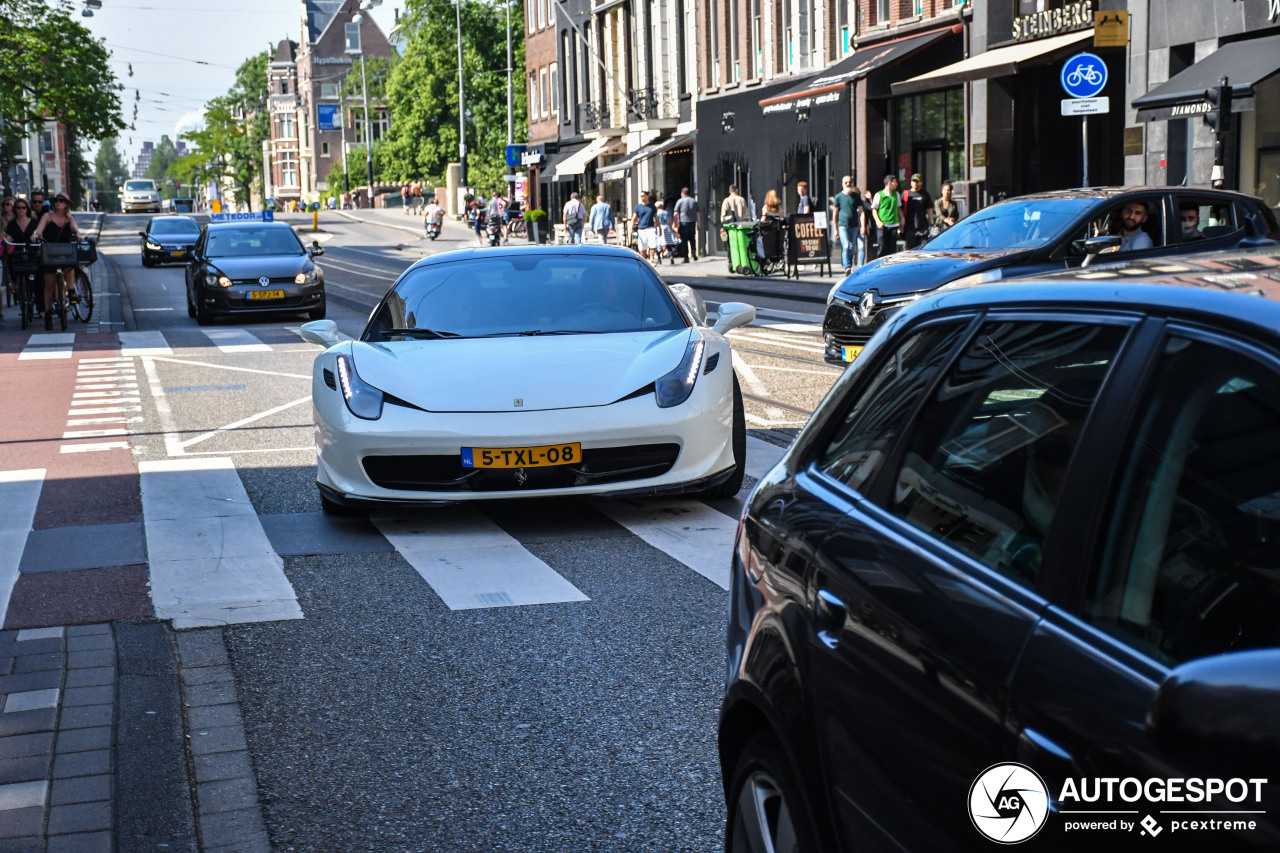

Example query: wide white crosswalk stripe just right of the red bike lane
[138,457,302,629]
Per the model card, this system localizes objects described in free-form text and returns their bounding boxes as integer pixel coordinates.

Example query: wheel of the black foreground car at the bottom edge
[724,731,819,853]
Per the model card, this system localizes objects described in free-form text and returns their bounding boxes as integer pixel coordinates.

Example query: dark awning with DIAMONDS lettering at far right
[1133,36,1280,122]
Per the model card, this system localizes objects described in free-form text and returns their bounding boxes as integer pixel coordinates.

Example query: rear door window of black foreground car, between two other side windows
[888,315,1128,589]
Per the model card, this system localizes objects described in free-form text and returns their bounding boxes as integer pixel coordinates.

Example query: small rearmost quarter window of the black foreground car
[818,324,964,489]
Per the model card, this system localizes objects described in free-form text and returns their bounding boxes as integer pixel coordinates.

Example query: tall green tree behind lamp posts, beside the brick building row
[370,0,527,187]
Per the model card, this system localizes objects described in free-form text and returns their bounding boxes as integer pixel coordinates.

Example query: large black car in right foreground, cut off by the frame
[719,248,1280,852]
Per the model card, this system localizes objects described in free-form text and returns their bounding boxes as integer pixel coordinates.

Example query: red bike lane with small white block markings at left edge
[0,332,152,629]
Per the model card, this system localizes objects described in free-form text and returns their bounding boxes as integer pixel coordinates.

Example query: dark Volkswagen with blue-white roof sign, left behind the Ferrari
[187,220,325,325]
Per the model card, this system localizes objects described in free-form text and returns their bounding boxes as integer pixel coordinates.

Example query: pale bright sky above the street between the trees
[77,0,404,168]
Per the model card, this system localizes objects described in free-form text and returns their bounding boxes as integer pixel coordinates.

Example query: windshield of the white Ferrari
[362,251,687,341]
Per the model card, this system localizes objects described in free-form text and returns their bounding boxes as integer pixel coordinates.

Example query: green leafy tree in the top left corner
[0,0,125,145]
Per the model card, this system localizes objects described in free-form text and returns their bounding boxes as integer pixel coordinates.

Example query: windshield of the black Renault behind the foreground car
[922,199,1098,251]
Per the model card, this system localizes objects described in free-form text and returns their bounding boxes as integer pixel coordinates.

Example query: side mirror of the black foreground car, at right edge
[1147,648,1280,749]
